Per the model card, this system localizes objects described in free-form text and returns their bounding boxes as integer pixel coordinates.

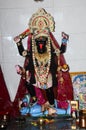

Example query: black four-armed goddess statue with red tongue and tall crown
[14,9,73,115]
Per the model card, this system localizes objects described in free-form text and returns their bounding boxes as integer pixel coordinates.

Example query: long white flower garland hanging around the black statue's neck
[32,37,51,85]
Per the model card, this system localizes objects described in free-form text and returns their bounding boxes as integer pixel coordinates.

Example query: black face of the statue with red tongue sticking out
[35,36,48,54]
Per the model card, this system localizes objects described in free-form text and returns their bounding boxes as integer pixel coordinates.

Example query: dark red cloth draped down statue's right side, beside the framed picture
[50,33,73,100]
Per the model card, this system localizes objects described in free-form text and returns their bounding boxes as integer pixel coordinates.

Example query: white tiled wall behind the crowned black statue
[0,0,86,101]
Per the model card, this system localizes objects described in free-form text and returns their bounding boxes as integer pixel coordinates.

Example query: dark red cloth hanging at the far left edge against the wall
[0,66,12,115]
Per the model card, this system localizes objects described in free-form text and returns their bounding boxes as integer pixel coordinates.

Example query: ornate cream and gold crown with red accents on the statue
[29,8,55,35]
